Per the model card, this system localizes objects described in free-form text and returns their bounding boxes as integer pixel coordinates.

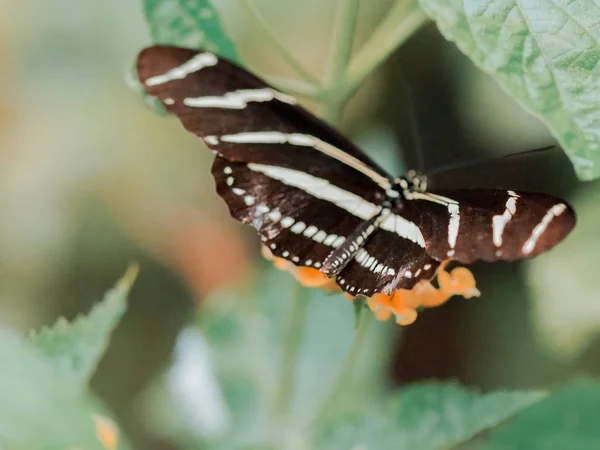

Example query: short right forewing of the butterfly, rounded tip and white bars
[406,189,576,263]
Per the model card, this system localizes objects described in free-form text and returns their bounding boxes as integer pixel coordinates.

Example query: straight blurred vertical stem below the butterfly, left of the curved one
[275,282,309,419]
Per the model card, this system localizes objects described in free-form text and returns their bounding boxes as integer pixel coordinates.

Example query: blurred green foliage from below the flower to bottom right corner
[141,269,600,450]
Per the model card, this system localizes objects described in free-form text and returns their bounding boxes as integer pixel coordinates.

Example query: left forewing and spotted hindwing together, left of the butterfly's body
[137,46,398,276]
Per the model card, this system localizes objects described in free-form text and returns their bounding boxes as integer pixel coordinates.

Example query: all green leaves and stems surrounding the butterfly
[0,0,600,450]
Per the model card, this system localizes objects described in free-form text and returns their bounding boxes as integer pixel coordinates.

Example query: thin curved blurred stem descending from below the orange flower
[308,300,371,426]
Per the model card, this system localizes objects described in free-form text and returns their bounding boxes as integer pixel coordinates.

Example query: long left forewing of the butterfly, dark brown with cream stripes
[137,46,390,202]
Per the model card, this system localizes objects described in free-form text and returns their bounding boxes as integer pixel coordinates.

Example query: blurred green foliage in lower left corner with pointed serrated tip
[0,267,137,450]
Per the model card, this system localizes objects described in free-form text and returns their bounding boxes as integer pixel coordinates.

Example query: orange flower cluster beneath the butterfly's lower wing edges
[262,247,480,325]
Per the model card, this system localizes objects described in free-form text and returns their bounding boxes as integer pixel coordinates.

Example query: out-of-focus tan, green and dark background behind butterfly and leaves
[0,0,600,448]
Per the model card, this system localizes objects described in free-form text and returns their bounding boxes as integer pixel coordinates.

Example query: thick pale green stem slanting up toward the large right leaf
[346,0,428,94]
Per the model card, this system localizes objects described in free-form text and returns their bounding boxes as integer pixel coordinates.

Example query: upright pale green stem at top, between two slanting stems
[323,0,359,124]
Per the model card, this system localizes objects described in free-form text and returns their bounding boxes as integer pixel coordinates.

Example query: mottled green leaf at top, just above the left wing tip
[144,0,240,63]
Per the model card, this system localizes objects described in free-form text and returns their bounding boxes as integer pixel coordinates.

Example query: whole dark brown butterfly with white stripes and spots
[137,46,575,296]
